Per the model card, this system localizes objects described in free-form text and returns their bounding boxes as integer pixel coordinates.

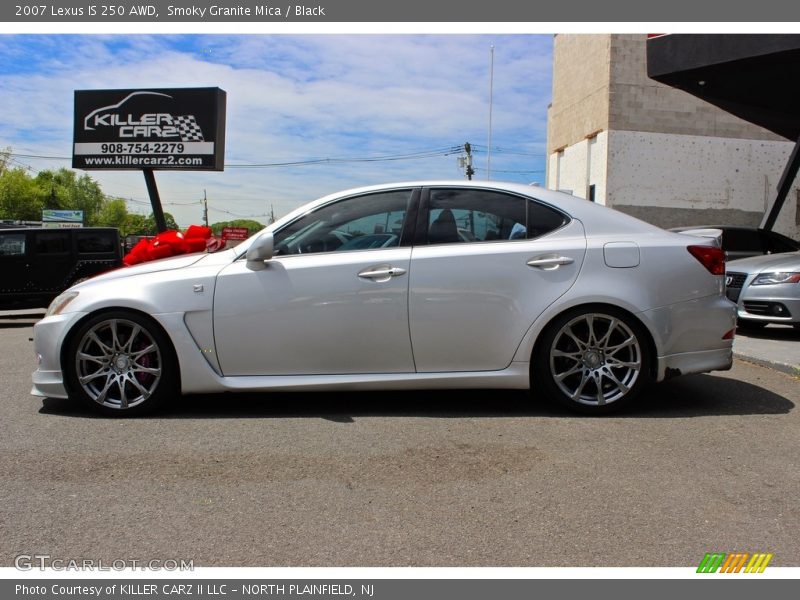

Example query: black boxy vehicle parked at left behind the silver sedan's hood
[0,227,122,310]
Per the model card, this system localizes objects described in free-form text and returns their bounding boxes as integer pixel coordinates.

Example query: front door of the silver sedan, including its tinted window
[214,189,418,376]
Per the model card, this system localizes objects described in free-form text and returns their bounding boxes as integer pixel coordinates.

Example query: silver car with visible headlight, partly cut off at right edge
[725,252,800,328]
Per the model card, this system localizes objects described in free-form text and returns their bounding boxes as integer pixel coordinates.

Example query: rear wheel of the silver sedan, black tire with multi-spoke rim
[531,306,652,415]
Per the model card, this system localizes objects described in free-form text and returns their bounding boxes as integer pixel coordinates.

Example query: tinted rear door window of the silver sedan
[428,189,566,244]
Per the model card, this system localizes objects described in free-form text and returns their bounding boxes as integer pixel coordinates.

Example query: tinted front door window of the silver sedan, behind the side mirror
[275,190,411,255]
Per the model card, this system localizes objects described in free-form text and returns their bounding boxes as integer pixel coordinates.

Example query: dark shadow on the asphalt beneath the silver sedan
[40,375,795,423]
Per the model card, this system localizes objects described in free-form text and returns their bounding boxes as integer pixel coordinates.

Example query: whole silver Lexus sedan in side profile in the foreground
[32,181,735,416]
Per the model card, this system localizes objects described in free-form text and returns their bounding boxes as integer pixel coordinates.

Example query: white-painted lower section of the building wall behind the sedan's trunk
[607,131,793,232]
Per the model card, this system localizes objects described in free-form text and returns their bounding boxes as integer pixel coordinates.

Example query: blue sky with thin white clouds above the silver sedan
[0,34,552,227]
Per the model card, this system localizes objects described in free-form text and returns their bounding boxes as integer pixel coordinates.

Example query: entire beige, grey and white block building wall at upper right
[547,34,800,238]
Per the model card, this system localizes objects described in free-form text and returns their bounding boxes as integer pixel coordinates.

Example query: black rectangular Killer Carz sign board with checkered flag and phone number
[72,88,226,171]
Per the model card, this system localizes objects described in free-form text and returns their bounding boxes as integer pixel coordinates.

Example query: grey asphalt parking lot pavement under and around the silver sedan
[0,314,800,566]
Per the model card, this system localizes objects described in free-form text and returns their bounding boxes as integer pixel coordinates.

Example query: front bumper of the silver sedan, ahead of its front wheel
[31,313,86,398]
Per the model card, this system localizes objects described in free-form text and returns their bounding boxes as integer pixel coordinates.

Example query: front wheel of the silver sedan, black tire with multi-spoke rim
[62,310,178,417]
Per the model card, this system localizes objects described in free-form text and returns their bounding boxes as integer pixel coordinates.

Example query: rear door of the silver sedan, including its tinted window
[409,187,586,373]
